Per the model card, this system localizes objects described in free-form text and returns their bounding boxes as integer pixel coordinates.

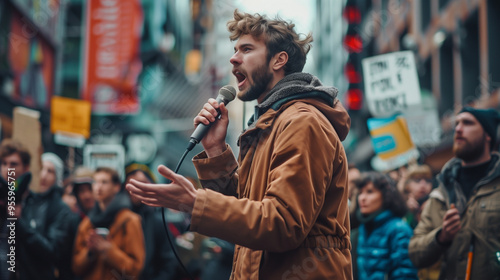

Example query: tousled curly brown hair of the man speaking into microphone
[227,9,313,75]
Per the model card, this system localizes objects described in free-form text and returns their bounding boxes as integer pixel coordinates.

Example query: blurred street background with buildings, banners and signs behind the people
[0,0,500,274]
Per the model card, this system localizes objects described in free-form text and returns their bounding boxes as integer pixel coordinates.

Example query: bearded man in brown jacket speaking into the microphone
[127,10,352,280]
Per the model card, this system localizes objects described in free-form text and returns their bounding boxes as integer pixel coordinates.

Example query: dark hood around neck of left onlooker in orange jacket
[89,192,132,228]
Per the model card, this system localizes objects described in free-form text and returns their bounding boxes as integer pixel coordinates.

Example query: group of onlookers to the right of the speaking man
[350,107,500,279]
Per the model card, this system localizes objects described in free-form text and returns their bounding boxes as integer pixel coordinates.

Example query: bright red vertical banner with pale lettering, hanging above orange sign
[82,0,144,115]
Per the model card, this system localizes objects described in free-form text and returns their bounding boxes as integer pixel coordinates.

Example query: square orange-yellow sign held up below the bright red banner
[50,96,91,138]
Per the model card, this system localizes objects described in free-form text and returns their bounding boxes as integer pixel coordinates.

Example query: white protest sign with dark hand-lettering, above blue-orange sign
[362,51,420,117]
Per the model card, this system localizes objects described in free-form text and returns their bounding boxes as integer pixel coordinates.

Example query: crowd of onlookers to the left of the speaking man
[0,139,232,280]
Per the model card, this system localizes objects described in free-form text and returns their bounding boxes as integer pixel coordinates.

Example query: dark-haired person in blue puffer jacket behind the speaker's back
[351,172,418,280]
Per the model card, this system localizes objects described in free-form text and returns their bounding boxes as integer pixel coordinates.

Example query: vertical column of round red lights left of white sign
[343,0,363,112]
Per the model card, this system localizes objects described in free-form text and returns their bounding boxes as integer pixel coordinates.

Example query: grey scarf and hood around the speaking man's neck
[249,73,351,141]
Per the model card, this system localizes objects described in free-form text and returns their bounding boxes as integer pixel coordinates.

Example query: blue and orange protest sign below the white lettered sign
[367,116,418,171]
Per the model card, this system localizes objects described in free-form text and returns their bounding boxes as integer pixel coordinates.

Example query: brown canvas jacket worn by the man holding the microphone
[191,99,352,279]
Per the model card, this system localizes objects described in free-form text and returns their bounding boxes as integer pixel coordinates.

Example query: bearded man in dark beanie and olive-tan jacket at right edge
[409,107,500,279]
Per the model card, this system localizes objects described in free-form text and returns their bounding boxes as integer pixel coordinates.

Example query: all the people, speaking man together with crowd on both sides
[0,8,500,280]
